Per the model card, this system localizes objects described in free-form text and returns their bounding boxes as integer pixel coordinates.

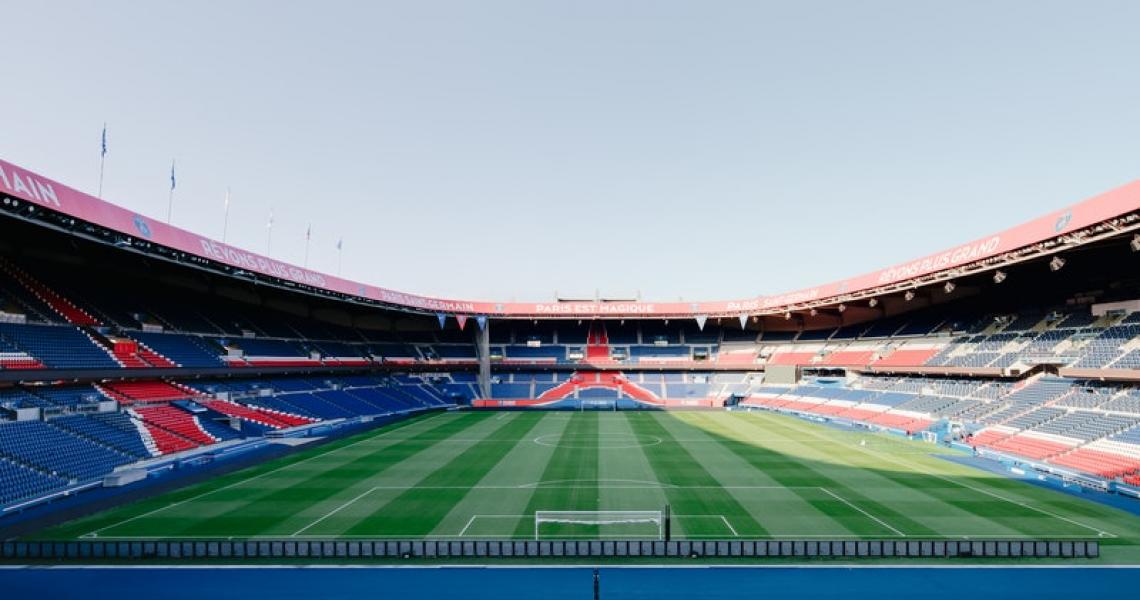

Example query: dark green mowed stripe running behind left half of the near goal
[514,413,600,537]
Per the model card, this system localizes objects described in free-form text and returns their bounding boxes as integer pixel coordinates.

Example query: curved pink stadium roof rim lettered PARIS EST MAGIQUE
[0,160,1140,318]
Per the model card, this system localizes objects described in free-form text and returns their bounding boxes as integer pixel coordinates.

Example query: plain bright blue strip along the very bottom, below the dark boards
[0,567,1140,600]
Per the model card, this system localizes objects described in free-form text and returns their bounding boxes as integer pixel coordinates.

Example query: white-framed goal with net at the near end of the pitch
[535,510,665,540]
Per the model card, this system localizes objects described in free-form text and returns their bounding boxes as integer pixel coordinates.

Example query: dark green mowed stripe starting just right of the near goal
[629,413,768,537]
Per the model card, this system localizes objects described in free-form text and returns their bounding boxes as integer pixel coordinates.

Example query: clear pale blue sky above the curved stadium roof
[0,0,1140,300]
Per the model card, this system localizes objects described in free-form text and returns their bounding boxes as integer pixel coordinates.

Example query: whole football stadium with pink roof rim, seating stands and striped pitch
[0,162,1140,593]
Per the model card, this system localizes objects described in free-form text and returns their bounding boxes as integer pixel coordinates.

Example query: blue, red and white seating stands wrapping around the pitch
[8,156,1140,517]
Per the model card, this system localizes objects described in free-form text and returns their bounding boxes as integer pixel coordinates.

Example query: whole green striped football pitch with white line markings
[33,412,1140,561]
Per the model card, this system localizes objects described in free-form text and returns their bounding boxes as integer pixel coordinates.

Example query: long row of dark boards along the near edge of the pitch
[0,537,1100,563]
